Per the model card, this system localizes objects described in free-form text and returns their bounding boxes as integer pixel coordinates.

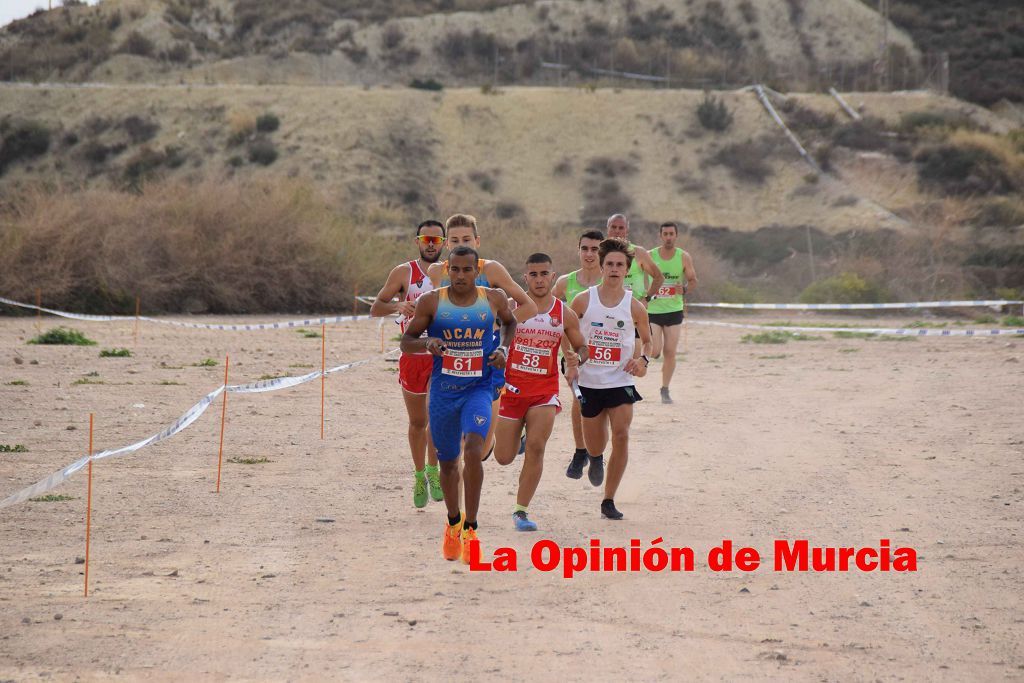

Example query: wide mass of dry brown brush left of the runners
[0,179,410,313]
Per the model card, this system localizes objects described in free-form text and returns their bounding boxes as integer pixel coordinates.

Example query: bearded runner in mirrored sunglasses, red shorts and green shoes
[370,220,444,508]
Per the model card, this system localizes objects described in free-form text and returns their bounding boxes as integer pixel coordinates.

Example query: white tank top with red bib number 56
[580,287,636,389]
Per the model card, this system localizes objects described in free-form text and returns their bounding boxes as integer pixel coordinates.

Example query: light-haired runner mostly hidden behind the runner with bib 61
[427,213,537,460]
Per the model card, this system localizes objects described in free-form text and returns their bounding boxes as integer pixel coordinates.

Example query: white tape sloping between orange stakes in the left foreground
[0,356,385,509]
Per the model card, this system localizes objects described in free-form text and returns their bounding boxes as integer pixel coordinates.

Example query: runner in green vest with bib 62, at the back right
[647,221,697,403]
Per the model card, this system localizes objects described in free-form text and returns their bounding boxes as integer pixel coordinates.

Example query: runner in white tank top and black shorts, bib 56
[571,238,650,519]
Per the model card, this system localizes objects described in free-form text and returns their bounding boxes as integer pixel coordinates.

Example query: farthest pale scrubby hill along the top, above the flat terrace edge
[0,0,918,90]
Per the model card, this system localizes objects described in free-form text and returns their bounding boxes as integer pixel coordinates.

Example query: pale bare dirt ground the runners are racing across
[0,315,1024,681]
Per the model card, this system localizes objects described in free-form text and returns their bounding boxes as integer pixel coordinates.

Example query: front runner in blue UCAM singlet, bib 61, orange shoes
[401,247,516,564]
